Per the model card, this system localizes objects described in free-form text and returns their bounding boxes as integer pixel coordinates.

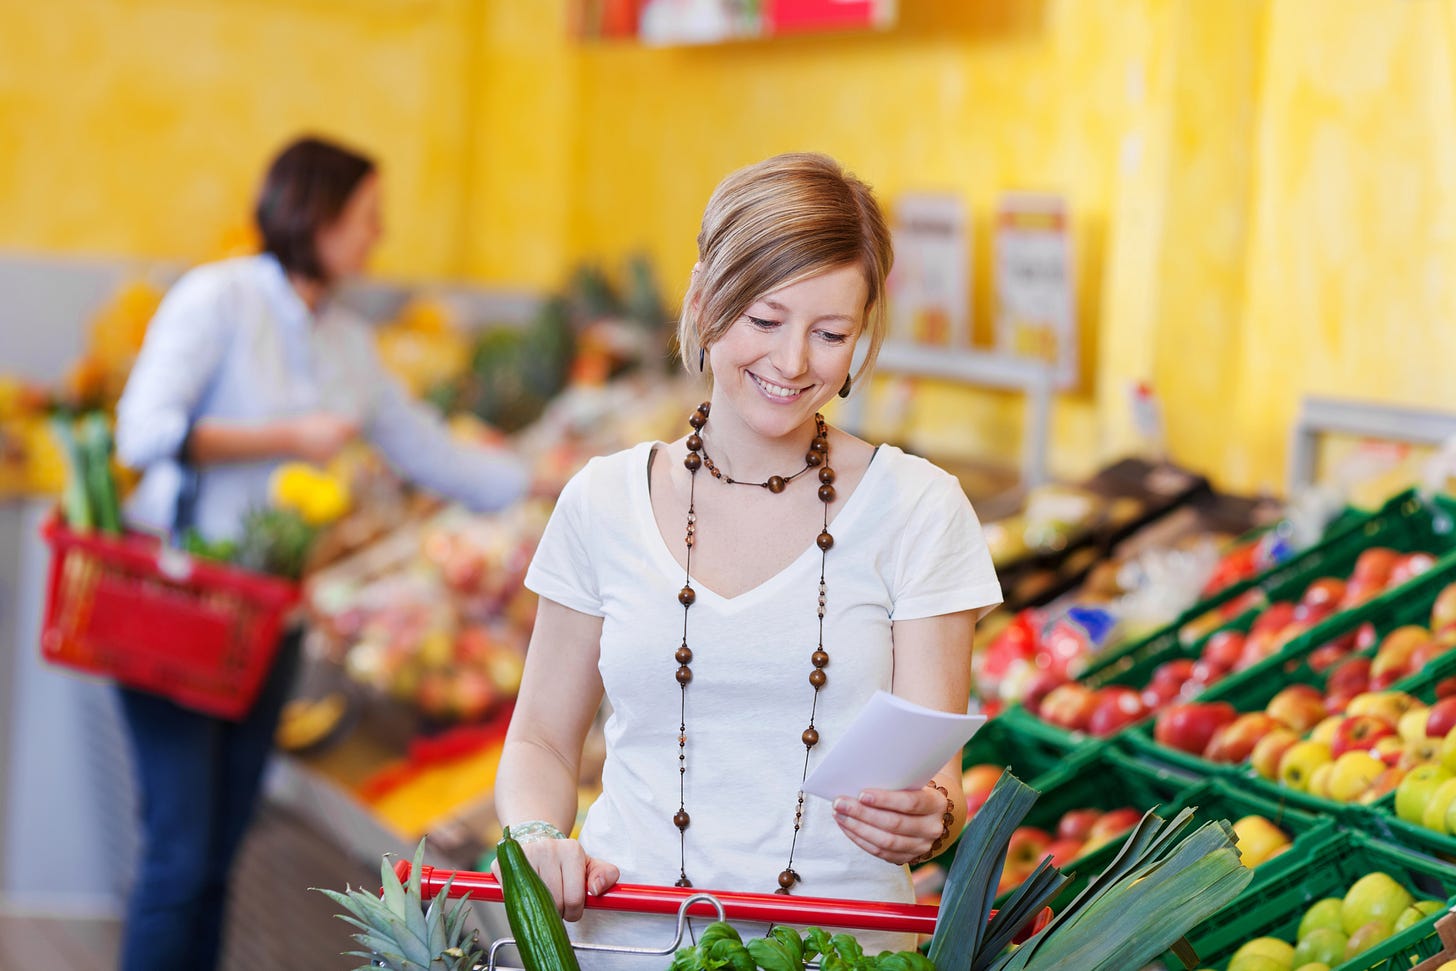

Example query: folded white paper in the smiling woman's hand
[804,691,986,799]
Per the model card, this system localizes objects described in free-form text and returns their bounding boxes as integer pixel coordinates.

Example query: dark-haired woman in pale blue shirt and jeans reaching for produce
[116,138,527,971]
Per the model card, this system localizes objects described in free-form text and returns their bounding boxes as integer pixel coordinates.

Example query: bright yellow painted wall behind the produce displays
[8,0,1456,489]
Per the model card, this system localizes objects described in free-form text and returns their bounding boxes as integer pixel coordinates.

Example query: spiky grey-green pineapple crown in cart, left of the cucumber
[314,840,483,971]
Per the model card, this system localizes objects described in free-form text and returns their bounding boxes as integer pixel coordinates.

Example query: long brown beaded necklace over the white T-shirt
[673,402,834,894]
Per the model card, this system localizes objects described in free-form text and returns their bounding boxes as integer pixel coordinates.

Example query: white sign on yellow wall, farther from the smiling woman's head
[994,192,1077,387]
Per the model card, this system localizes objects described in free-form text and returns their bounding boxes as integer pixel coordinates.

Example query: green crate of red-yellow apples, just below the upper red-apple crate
[1118,553,1456,797]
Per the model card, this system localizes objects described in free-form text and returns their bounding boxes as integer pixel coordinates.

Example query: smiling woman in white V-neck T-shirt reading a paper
[496,154,1000,968]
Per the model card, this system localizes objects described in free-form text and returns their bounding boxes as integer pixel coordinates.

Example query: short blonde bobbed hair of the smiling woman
[677,153,894,383]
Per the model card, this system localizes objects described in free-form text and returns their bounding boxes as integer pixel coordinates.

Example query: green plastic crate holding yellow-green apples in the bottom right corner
[1165,830,1456,971]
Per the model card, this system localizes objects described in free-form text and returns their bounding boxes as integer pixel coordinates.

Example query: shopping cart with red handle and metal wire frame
[395,860,1051,971]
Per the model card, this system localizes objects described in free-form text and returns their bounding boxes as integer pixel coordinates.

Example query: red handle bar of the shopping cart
[395,860,1051,940]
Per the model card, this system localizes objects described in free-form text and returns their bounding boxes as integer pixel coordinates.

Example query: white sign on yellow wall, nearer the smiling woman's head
[888,194,971,348]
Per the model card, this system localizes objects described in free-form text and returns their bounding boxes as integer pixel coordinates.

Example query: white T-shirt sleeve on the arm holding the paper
[891,463,1002,620]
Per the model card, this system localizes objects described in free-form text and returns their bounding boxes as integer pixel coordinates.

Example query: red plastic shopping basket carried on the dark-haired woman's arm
[41,517,298,719]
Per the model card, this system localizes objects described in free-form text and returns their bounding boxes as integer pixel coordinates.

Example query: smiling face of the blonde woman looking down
[708,266,869,438]
